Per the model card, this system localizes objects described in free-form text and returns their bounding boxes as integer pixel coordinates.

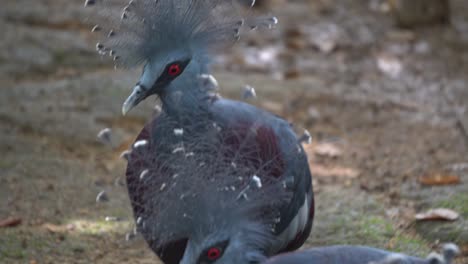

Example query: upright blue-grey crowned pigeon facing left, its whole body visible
[85,0,314,264]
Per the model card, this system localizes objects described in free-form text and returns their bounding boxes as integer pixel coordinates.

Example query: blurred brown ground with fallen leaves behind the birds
[0,0,468,264]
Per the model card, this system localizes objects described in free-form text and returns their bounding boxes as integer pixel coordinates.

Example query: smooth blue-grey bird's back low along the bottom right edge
[262,244,459,264]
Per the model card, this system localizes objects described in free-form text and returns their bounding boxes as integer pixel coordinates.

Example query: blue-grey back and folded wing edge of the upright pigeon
[211,99,314,253]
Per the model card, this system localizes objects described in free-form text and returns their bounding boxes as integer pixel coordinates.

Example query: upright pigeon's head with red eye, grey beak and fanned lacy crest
[85,0,277,114]
